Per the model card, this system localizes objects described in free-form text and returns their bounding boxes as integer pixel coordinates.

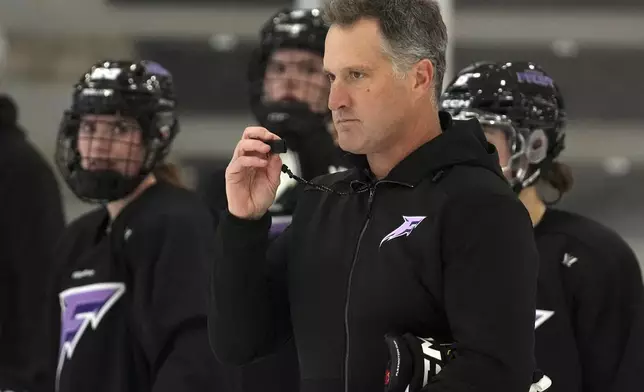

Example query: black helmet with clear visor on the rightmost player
[441,61,566,192]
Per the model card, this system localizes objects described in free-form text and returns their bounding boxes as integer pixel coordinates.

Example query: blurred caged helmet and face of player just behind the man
[249,9,330,136]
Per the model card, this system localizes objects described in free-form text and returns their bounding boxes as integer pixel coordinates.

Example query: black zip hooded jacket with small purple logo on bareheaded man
[209,113,538,392]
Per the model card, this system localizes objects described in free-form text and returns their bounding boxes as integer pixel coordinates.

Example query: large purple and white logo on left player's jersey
[56,283,125,384]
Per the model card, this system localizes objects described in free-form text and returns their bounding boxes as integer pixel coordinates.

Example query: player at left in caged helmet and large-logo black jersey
[50,61,226,392]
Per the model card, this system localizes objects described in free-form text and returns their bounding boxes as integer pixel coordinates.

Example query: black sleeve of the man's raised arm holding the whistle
[208,212,292,365]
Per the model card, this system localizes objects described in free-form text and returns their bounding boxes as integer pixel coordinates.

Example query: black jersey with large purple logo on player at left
[49,182,229,392]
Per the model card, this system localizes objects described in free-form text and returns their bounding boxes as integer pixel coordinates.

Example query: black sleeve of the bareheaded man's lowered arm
[426,195,539,392]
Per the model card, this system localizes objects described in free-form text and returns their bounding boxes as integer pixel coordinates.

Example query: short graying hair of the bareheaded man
[322,0,447,103]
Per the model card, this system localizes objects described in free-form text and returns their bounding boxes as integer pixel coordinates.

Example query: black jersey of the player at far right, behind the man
[535,209,644,392]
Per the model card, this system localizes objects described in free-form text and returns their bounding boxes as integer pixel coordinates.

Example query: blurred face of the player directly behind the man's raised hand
[262,49,329,114]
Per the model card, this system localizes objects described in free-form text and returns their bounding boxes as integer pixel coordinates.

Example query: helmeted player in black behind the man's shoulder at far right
[441,62,644,392]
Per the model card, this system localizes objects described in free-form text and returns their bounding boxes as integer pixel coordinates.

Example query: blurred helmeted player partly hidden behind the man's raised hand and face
[203,8,345,234]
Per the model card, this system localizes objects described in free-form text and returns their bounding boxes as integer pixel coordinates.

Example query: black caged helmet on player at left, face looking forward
[55,60,179,203]
